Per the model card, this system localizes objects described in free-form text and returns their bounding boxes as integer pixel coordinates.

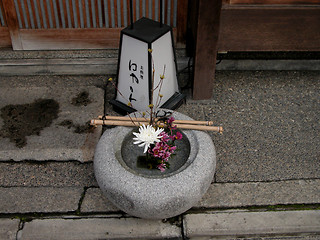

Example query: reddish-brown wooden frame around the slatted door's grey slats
[0,0,188,50]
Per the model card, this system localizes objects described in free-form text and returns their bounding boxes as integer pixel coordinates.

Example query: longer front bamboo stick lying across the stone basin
[91,119,223,133]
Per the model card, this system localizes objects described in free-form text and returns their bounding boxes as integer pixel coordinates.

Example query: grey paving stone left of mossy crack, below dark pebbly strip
[0,187,83,213]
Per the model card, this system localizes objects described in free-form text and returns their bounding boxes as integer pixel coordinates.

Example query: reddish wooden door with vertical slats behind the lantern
[2,0,187,50]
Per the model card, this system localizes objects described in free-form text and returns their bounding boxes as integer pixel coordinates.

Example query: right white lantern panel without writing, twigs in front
[152,31,179,106]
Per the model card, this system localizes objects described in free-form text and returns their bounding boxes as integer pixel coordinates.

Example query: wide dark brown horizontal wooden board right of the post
[218,5,320,52]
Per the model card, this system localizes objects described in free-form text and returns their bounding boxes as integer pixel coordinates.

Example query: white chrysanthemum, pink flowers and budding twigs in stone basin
[109,49,182,172]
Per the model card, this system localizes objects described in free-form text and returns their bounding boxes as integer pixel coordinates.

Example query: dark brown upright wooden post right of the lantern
[193,0,222,100]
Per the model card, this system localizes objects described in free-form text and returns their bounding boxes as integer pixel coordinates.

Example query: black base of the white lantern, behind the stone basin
[109,92,186,115]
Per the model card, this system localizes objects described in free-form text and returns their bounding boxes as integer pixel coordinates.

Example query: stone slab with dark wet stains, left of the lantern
[0,86,104,162]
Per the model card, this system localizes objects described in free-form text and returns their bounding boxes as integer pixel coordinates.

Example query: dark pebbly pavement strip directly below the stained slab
[0,161,97,187]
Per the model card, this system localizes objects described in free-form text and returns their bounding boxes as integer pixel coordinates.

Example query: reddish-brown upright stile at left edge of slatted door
[2,0,23,50]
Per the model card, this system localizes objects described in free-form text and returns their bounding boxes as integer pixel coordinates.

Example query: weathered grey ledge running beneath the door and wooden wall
[0,49,320,76]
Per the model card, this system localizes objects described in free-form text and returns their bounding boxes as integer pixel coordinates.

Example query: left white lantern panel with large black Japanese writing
[116,34,149,111]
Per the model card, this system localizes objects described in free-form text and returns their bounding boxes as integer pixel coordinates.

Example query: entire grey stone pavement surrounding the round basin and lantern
[0,49,320,239]
